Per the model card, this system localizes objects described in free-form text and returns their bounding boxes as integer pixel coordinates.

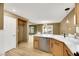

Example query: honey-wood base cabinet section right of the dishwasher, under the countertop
[50,39,73,56]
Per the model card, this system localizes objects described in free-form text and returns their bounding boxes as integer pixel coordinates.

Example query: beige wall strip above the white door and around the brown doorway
[5,11,29,47]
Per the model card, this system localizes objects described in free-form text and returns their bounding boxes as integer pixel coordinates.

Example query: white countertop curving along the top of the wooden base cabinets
[34,34,79,53]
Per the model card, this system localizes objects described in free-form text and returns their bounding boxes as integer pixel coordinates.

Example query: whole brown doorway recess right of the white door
[17,19,27,44]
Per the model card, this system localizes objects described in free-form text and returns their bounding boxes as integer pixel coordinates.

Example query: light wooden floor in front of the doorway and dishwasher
[5,42,52,56]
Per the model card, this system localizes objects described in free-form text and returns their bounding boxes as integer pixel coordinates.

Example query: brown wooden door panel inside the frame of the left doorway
[18,19,26,43]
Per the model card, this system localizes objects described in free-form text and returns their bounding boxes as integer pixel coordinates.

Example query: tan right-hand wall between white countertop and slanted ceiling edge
[60,9,75,34]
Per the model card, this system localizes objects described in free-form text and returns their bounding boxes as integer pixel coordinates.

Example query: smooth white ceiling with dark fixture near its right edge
[5,3,75,24]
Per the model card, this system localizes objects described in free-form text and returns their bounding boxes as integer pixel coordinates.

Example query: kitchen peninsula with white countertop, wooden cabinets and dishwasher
[34,34,79,56]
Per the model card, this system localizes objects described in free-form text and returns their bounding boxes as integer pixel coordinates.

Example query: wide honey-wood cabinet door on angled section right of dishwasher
[52,41,63,56]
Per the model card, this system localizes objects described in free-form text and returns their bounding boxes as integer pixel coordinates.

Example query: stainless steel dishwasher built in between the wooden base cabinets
[39,37,49,52]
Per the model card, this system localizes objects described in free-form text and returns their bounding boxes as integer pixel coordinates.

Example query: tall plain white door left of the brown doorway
[4,16,16,51]
